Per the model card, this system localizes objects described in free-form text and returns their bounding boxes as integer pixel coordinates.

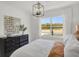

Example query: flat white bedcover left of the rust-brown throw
[11,39,58,57]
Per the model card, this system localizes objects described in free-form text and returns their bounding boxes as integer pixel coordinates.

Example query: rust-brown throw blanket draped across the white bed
[48,42,64,57]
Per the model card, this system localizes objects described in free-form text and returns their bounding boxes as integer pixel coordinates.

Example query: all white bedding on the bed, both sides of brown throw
[11,35,79,57]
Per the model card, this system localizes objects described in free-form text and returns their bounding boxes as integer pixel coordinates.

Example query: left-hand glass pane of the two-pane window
[41,18,50,35]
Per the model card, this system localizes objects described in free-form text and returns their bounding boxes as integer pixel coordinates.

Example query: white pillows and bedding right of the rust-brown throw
[64,35,79,57]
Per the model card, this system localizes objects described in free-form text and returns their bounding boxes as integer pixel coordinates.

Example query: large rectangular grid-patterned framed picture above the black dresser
[4,16,21,35]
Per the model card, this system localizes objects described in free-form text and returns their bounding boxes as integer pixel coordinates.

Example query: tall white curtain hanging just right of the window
[64,7,74,35]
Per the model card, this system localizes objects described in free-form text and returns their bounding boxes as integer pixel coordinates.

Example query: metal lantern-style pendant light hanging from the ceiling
[32,2,44,17]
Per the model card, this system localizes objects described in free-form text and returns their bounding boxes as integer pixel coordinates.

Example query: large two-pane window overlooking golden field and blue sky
[40,16,64,35]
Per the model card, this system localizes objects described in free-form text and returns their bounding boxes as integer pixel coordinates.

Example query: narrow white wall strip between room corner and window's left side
[30,15,39,41]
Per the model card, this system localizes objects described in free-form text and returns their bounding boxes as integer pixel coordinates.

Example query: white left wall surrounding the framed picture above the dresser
[0,2,30,42]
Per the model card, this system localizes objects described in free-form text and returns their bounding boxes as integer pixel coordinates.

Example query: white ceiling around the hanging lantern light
[2,1,77,12]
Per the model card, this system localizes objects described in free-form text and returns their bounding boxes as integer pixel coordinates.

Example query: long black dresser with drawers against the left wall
[0,34,28,57]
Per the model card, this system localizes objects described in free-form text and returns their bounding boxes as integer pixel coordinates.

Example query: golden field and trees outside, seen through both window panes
[41,24,63,35]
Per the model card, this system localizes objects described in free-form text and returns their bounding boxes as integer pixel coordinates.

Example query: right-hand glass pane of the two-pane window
[52,16,64,35]
